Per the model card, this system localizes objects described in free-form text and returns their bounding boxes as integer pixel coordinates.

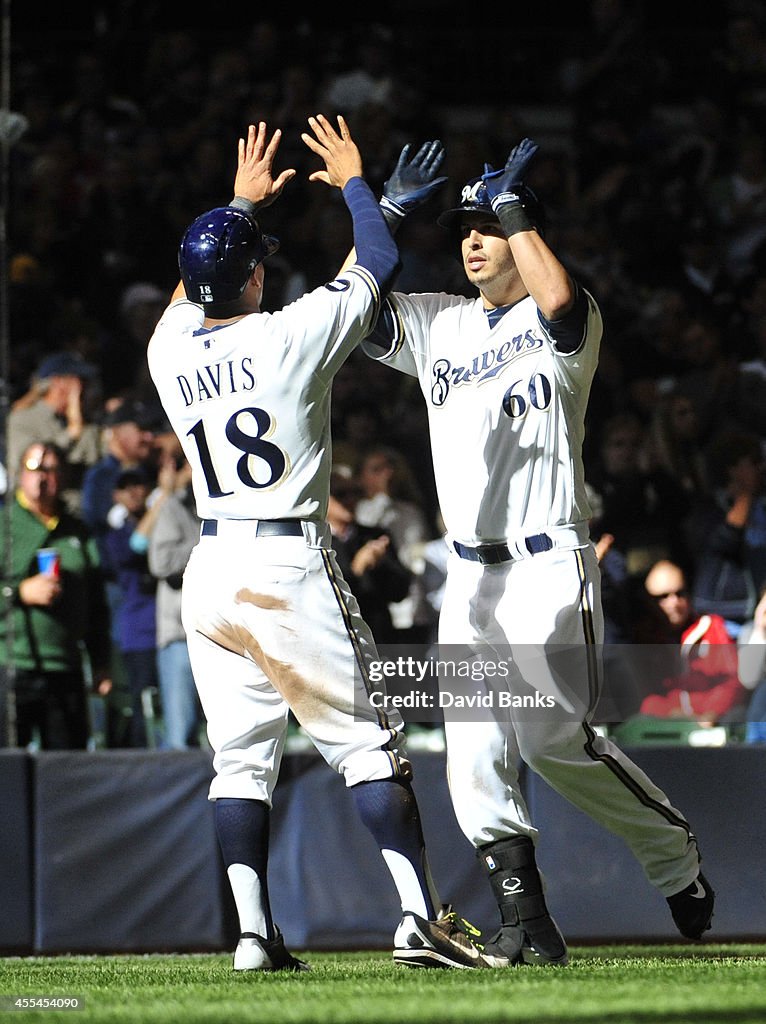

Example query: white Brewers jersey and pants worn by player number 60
[366,292,699,895]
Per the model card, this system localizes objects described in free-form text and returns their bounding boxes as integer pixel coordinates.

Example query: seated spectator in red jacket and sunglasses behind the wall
[640,560,748,725]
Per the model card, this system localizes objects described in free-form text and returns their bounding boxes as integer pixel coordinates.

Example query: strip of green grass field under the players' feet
[0,943,766,1024]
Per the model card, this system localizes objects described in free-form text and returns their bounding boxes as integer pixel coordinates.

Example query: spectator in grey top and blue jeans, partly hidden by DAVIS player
[147,445,204,751]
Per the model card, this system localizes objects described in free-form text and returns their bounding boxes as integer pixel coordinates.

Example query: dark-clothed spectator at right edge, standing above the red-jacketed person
[685,432,766,636]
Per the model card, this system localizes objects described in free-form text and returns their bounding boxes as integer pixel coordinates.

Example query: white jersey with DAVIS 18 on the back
[148,266,380,520]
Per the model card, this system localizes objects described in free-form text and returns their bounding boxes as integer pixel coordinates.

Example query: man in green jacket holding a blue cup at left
[0,442,111,750]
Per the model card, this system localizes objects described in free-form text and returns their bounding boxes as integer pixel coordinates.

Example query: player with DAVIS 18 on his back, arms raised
[148,115,486,971]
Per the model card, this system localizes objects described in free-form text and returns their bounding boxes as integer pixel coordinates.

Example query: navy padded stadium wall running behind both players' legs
[0,746,766,955]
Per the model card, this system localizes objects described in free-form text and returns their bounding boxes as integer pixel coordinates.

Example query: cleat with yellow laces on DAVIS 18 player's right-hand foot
[393,907,487,971]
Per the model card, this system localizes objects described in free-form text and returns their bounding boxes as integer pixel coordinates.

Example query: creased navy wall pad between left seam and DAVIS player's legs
[34,750,238,953]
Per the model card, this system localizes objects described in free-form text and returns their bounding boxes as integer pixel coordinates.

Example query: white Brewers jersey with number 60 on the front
[367,293,602,545]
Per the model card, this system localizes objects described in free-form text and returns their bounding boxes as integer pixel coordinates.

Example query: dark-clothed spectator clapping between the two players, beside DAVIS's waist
[327,467,412,644]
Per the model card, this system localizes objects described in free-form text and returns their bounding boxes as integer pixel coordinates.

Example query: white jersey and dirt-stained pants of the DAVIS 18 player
[148,265,410,803]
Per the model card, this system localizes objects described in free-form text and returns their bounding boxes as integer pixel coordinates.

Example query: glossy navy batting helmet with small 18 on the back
[178,206,280,305]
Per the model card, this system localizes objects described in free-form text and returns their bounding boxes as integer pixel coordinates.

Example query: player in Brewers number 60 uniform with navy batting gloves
[365,139,714,966]
